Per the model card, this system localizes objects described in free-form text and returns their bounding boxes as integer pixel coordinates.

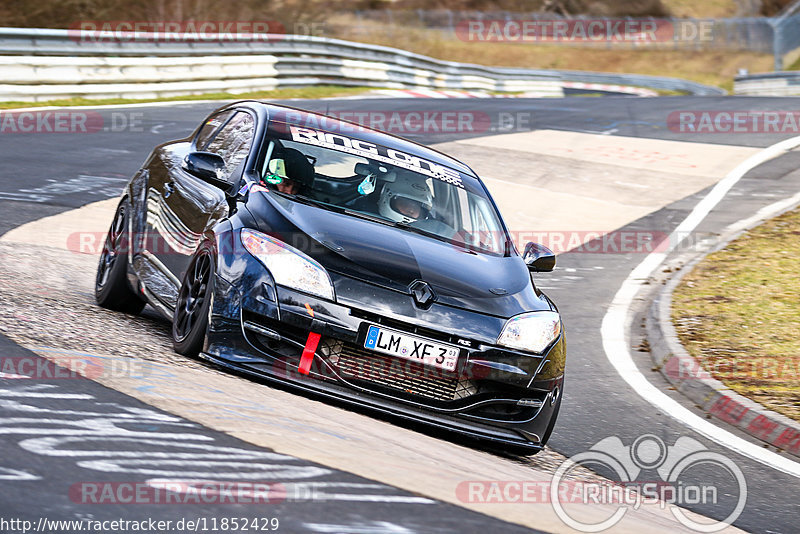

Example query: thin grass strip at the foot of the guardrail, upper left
[0,85,373,109]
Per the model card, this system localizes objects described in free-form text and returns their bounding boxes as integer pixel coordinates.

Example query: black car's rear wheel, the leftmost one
[94,201,145,313]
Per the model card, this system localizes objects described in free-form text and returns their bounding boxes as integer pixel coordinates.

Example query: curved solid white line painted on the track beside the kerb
[600,137,800,478]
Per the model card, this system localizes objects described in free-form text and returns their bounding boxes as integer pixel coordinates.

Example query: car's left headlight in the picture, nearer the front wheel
[241,228,333,300]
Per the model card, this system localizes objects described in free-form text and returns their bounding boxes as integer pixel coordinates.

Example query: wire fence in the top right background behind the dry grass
[349,9,800,70]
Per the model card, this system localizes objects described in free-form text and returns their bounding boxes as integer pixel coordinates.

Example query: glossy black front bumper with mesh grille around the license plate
[209,258,565,450]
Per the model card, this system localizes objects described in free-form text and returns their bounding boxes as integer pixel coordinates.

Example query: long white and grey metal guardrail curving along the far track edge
[0,28,724,101]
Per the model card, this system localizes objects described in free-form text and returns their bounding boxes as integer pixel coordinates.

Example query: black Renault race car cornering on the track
[95,101,566,451]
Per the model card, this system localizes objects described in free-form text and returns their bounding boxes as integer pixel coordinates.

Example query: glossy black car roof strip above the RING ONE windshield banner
[226,100,480,183]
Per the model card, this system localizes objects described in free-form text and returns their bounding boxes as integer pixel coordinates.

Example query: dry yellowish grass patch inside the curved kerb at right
[672,209,800,421]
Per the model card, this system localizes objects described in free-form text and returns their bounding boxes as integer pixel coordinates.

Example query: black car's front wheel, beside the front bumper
[172,244,216,356]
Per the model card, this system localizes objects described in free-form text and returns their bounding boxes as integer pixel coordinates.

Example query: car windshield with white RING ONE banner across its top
[259,126,508,255]
